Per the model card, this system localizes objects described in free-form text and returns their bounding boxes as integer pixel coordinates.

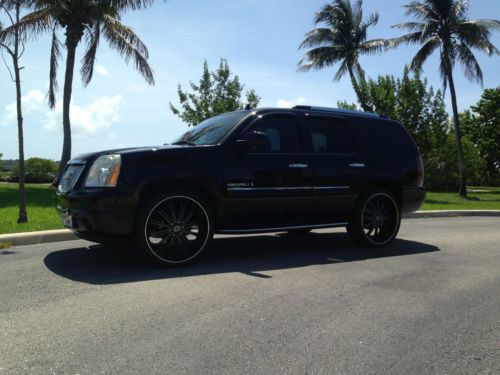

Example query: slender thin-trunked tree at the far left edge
[0,0,28,223]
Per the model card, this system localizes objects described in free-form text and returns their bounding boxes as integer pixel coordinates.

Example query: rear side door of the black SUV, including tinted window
[302,114,364,219]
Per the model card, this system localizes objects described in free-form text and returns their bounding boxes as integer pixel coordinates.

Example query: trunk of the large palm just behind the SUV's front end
[57,37,78,181]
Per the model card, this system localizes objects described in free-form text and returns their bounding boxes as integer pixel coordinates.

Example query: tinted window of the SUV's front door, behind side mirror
[248,115,300,153]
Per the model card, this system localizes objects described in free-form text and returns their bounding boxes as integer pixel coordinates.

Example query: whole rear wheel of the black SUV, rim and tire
[347,190,401,247]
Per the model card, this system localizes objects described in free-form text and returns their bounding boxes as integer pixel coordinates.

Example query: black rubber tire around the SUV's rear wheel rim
[346,189,401,248]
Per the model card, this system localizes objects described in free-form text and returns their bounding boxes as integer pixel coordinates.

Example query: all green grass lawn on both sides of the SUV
[0,183,500,234]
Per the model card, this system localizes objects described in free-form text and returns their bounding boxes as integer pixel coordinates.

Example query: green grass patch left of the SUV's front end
[0,183,63,234]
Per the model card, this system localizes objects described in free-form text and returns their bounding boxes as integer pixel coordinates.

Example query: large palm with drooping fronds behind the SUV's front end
[21,0,158,182]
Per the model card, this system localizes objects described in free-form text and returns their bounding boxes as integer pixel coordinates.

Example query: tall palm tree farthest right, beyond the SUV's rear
[388,0,500,197]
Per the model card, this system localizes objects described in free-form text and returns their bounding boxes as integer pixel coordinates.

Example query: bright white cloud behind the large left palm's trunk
[44,95,123,136]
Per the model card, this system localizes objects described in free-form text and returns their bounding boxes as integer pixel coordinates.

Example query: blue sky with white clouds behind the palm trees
[0,0,500,160]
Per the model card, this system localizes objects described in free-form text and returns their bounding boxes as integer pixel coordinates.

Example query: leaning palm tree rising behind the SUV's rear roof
[299,0,385,111]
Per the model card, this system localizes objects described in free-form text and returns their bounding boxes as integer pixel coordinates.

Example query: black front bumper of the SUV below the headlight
[56,188,137,242]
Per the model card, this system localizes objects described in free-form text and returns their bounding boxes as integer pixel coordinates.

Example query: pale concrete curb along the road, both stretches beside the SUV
[0,210,500,246]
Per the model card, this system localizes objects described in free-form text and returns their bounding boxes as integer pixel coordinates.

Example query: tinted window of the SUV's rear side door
[305,117,354,154]
